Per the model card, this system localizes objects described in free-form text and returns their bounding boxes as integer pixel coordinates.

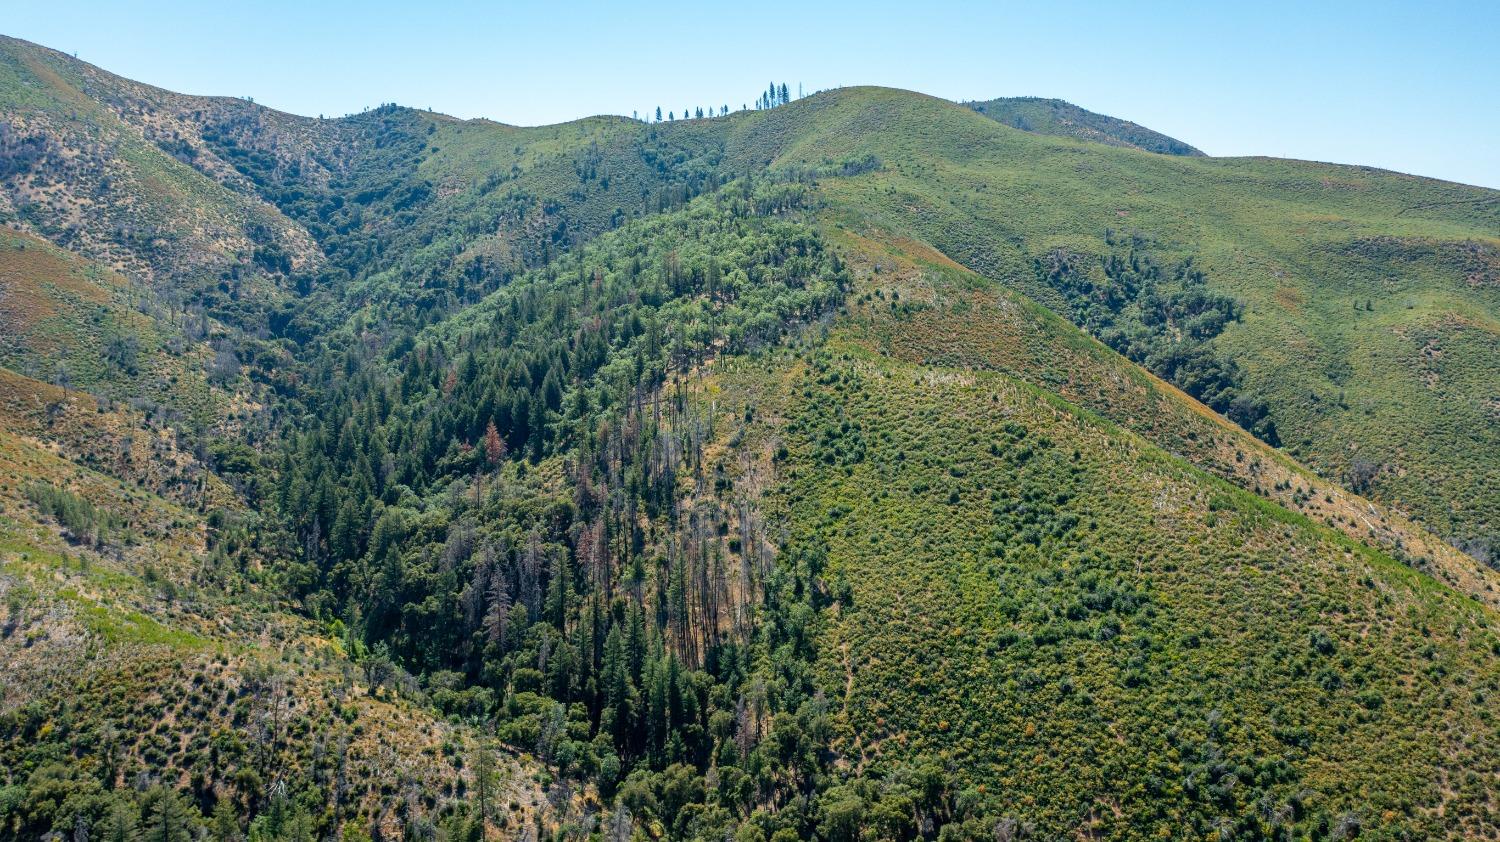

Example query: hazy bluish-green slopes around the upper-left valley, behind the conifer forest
[0,33,722,342]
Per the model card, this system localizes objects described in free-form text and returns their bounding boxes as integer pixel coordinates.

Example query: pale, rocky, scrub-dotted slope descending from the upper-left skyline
[0,38,318,323]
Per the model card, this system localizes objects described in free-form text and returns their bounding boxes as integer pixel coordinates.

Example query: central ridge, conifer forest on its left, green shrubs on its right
[252,180,1500,839]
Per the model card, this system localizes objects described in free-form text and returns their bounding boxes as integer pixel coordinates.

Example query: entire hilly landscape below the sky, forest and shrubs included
[0,39,1500,842]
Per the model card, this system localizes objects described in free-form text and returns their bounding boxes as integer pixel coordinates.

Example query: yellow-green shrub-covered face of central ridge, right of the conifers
[687,243,1500,839]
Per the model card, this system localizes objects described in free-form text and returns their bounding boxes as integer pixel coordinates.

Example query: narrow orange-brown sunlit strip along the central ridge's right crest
[840,233,1500,608]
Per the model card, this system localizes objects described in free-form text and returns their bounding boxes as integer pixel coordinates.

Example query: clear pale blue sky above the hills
[11,0,1500,188]
